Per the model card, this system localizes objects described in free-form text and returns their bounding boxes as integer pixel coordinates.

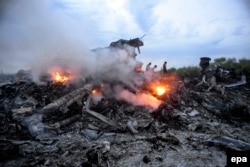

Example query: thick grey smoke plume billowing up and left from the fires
[0,0,154,107]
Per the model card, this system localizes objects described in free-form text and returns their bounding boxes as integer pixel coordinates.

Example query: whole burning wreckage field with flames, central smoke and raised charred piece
[0,38,250,167]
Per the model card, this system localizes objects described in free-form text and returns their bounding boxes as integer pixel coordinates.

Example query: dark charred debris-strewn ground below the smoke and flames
[0,71,250,167]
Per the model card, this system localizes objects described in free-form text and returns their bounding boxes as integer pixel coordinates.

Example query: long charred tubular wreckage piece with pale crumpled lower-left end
[16,85,89,139]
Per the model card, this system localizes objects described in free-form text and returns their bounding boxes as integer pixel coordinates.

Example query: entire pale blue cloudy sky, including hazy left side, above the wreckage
[0,0,250,72]
